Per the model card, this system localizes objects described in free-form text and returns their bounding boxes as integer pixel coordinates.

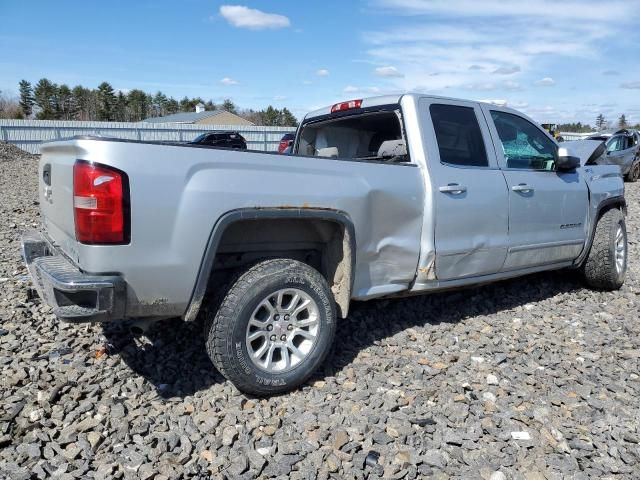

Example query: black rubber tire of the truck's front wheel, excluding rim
[582,208,628,290]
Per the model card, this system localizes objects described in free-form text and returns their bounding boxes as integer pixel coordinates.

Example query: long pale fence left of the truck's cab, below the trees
[0,119,295,153]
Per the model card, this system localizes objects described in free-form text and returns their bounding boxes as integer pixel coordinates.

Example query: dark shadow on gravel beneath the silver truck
[103,272,582,398]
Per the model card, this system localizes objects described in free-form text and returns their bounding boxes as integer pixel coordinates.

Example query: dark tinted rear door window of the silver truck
[429,104,489,167]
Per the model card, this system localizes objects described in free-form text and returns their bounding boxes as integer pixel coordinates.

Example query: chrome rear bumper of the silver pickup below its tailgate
[22,231,126,322]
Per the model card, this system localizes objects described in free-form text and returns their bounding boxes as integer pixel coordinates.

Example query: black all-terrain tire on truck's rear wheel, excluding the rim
[204,259,336,396]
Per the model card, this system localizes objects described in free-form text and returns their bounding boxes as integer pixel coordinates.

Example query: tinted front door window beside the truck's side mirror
[491,110,558,171]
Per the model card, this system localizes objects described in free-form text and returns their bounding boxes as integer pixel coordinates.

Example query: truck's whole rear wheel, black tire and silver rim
[205,259,336,395]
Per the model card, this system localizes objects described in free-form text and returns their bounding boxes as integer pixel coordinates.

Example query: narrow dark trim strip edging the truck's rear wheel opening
[182,208,356,322]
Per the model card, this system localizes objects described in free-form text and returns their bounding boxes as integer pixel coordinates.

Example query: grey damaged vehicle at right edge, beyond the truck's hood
[588,129,640,182]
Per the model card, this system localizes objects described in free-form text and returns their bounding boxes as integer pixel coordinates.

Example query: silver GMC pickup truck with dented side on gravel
[22,94,627,395]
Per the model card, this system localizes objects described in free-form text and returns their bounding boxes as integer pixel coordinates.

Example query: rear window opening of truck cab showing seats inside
[297,111,407,161]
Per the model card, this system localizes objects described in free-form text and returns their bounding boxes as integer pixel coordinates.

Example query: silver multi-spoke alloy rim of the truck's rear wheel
[245,288,320,373]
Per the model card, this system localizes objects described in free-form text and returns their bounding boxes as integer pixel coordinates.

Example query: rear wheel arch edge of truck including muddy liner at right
[183,208,356,321]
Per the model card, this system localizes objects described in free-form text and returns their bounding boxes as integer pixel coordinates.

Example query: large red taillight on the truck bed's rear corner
[73,160,129,245]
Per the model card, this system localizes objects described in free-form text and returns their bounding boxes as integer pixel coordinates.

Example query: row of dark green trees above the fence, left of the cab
[0,78,298,127]
